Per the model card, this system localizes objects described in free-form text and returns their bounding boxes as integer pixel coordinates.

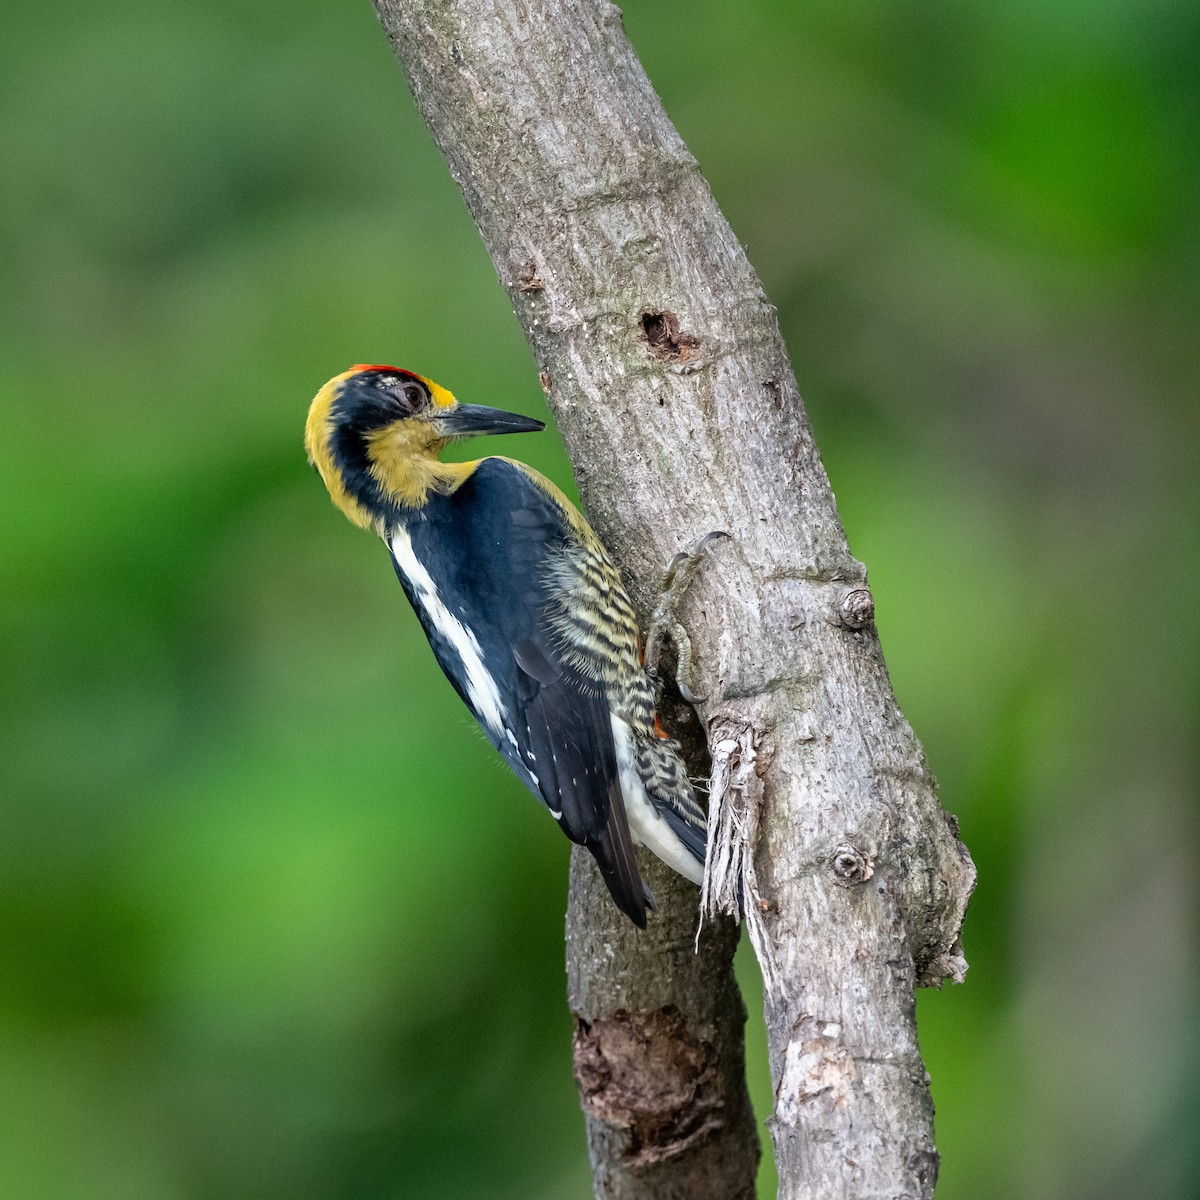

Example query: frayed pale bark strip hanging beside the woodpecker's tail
[696,722,784,996]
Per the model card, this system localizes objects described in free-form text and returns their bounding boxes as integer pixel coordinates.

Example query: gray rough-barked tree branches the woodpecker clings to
[376,0,974,1198]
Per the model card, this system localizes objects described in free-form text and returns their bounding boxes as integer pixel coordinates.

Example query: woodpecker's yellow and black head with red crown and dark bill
[305,364,545,532]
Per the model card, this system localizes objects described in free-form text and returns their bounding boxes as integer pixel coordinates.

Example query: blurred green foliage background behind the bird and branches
[0,0,1200,1200]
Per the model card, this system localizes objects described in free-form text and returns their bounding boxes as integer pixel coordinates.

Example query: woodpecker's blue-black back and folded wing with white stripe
[390,458,647,928]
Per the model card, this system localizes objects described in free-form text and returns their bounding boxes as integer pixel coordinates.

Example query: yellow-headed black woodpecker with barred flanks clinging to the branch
[305,364,707,929]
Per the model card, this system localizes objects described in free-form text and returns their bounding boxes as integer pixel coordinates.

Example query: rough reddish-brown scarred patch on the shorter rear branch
[572,1004,724,1168]
